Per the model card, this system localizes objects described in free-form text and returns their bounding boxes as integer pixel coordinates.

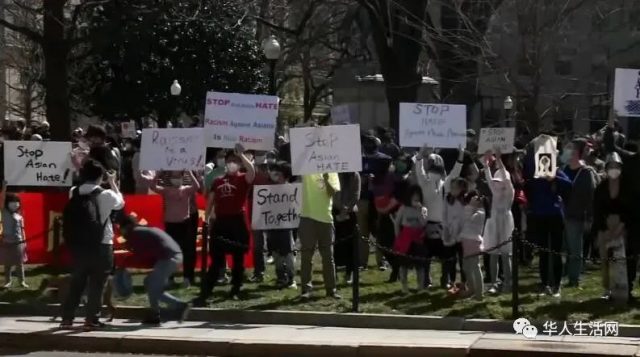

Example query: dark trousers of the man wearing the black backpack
[62,244,113,323]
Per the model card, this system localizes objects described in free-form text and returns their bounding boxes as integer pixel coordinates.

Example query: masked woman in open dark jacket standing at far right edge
[593,153,638,300]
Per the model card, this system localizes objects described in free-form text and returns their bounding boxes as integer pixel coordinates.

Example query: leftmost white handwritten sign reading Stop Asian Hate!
[4,141,73,187]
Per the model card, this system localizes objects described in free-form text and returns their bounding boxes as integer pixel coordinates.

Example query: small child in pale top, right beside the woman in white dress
[460,192,485,300]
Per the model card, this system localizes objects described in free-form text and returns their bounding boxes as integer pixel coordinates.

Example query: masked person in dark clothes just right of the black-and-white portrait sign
[560,139,596,287]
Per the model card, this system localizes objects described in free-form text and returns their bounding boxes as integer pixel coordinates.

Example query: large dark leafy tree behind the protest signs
[72,0,266,126]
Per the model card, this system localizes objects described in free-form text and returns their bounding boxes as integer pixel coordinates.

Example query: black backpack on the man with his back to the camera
[62,187,109,250]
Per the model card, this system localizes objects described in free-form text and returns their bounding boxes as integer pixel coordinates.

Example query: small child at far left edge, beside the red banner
[0,182,29,289]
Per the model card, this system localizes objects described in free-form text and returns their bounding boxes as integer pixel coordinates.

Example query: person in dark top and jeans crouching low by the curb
[120,216,189,325]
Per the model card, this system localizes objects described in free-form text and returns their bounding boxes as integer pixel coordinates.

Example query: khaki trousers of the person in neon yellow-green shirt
[298,217,336,294]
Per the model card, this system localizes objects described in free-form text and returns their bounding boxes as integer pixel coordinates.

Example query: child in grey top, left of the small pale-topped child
[443,177,468,295]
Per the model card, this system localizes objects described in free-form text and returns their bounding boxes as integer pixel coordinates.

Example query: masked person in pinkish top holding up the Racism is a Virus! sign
[151,171,200,287]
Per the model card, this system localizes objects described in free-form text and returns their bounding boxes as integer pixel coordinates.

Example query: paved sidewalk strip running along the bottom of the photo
[0,317,640,357]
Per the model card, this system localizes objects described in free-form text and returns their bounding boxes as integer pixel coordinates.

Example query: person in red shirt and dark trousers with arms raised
[193,144,256,306]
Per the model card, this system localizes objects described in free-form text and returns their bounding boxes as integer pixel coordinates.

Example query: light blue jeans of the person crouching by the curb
[144,254,185,314]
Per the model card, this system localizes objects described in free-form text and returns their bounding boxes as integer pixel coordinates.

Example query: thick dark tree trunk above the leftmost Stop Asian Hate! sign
[42,0,71,141]
